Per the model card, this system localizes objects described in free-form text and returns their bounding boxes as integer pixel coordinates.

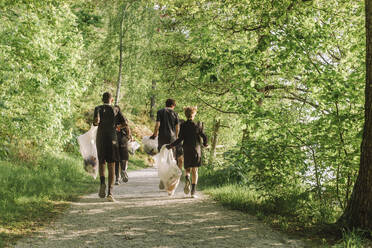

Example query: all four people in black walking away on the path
[93,92,208,201]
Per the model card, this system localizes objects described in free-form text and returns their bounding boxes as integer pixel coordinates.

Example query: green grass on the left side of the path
[0,154,97,247]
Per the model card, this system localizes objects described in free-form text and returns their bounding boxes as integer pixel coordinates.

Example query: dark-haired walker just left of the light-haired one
[150,99,180,189]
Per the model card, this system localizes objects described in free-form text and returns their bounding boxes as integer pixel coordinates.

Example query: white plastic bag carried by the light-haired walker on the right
[154,145,182,196]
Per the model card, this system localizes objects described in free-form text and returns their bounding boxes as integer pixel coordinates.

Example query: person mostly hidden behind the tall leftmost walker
[115,106,132,185]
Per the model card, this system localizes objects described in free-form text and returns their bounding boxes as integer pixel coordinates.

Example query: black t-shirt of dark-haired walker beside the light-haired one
[156,108,179,144]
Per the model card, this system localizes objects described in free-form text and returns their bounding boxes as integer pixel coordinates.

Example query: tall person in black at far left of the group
[93,92,125,201]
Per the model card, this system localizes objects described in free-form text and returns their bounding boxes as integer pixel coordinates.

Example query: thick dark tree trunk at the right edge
[339,0,372,230]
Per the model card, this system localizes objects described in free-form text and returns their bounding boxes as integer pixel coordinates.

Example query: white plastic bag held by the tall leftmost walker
[78,125,98,179]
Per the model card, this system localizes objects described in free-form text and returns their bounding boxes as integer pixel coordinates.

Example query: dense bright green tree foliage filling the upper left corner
[0,2,96,154]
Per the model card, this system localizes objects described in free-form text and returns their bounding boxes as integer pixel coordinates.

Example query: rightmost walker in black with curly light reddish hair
[167,107,208,198]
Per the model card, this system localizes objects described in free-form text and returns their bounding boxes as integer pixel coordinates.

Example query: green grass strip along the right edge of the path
[199,171,372,248]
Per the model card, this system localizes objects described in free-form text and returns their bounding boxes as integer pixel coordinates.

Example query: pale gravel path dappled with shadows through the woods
[16,169,311,248]
